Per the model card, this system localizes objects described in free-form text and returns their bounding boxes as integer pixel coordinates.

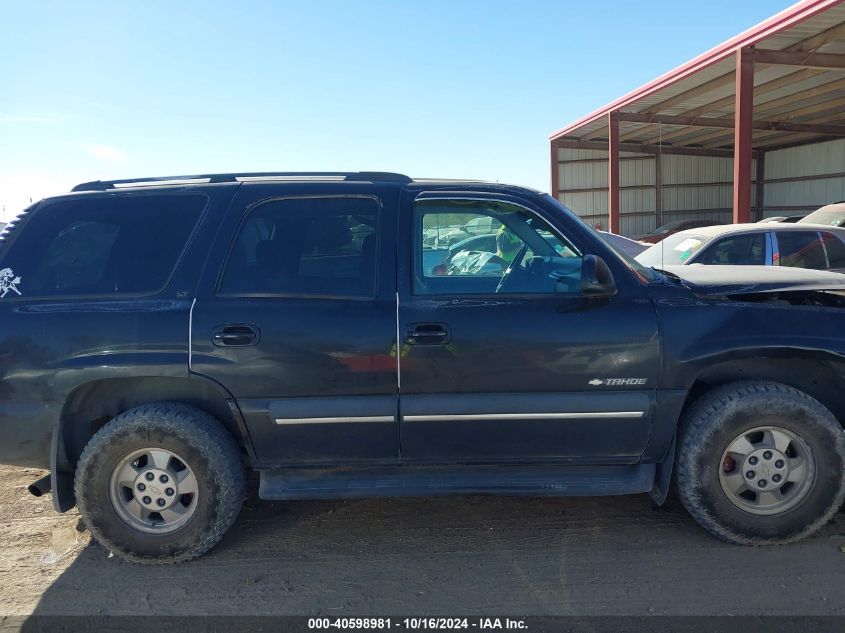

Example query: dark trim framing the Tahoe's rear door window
[213,193,384,301]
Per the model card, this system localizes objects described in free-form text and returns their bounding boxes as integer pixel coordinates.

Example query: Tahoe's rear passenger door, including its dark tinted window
[191,182,399,465]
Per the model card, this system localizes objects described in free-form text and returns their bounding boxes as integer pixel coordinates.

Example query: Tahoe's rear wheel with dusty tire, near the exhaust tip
[74,402,246,564]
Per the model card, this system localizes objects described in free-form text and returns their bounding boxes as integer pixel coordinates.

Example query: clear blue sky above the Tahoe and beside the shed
[0,0,789,220]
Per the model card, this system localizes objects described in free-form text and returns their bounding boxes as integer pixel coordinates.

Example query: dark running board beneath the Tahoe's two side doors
[258,464,655,500]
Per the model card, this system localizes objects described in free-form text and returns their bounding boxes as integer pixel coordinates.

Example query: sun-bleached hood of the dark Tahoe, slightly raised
[662,264,845,295]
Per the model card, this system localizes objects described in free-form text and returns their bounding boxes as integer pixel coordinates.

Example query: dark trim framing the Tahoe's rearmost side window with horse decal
[2,191,212,303]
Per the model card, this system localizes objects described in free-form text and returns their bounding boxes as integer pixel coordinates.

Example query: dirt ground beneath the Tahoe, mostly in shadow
[0,467,845,616]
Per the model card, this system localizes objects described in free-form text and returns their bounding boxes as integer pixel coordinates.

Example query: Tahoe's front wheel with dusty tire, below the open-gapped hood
[675,382,845,545]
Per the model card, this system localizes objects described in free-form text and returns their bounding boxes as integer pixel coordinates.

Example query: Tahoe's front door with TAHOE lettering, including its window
[399,193,658,463]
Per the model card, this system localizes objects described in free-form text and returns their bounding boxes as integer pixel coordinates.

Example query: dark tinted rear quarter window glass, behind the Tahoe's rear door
[2,194,208,298]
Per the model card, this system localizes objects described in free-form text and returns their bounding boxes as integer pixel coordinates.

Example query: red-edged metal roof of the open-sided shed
[549,0,845,149]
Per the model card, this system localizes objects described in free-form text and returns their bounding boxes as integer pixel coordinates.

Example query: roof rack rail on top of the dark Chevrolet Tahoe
[71,171,413,191]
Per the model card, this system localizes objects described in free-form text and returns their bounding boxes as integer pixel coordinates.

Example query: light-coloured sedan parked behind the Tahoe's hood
[637,223,845,273]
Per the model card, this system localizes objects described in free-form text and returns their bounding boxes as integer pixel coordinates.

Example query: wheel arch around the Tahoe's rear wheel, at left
[51,376,255,512]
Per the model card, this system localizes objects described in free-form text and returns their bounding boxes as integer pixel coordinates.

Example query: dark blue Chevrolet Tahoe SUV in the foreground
[0,173,845,563]
